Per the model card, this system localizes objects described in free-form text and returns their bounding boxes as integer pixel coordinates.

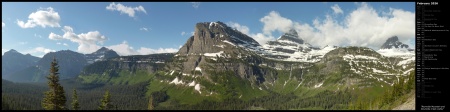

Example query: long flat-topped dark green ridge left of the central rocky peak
[78,53,174,84]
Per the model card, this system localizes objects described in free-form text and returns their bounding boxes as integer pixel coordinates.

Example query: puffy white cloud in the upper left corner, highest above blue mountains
[17,7,61,28]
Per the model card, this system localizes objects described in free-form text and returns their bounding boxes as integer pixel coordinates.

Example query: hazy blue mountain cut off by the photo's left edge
[2,49,40,79]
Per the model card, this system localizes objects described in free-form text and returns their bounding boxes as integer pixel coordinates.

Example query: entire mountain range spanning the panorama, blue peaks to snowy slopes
[2,21,415,109]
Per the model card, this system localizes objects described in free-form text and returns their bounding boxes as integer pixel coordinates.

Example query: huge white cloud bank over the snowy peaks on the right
[250,3,415,49]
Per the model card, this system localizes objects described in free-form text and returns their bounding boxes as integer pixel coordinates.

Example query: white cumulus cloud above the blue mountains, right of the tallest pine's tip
[48,26,107,54]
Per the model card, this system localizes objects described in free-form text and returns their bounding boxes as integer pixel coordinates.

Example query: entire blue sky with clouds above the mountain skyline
[2,2,415,57]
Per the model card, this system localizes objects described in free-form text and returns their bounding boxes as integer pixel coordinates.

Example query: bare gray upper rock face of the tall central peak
[176,22,259,73]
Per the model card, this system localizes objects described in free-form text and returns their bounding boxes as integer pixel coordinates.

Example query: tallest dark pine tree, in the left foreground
[42,58,66,110]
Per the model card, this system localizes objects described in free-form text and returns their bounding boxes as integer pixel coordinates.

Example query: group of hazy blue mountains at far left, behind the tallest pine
[2,47,119,82]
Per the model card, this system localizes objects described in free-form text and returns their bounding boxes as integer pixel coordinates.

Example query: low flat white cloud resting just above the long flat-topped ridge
[107,41,178,56]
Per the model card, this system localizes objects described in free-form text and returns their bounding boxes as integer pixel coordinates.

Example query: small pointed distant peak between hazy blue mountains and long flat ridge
[85,47,119,64]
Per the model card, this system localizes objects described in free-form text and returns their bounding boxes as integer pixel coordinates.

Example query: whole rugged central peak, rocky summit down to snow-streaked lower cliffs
[169,22,270,83]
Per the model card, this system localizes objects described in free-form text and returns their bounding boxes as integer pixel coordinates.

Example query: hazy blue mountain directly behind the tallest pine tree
[7,50,87,82]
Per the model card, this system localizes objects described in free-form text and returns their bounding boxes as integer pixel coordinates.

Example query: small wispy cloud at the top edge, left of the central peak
[106,2,147,17]
